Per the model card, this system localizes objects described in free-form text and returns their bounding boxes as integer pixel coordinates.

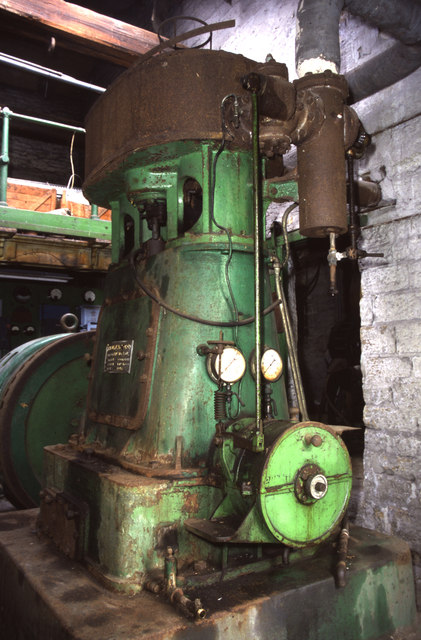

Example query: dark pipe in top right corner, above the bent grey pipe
[342,0,421,45]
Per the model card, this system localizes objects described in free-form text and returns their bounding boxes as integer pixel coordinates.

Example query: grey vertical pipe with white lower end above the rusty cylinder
[295,0,344,78]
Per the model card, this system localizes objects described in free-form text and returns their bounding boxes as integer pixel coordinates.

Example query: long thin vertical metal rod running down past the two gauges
[251,91,263,438]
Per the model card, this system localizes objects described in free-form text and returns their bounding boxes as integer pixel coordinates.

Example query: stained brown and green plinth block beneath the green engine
[0,516,415,640]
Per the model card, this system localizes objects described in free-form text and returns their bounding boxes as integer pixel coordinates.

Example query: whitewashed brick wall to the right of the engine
[357,69,421,604]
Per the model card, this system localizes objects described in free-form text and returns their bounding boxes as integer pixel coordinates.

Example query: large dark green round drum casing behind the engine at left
[0,331,95,508]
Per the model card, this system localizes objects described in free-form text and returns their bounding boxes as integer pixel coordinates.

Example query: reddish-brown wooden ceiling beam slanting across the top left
[0,0,159,67]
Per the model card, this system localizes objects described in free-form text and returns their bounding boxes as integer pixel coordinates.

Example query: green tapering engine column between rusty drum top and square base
[83,142,288,466]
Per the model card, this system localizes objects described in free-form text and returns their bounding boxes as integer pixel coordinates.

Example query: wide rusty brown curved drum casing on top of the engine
[85,50,262,187]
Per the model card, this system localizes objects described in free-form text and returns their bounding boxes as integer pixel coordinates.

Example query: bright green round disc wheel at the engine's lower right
[259,422,352,548]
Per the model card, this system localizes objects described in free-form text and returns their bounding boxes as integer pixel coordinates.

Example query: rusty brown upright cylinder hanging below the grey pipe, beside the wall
[294,72,348,238]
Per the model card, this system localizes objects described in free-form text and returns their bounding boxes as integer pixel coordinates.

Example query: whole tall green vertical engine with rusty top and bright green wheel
[0,50,416,639]
